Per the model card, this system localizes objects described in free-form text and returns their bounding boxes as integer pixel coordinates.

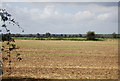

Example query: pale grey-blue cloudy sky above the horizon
[0,0,118,34]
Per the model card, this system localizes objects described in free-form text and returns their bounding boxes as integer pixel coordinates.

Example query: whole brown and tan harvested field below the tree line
[3,40,118,79]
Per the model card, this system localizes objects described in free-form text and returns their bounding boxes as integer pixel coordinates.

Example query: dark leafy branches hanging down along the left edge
[0,9,24,75]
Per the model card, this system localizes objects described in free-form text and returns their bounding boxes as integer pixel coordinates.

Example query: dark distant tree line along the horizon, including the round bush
[2,31,120,40]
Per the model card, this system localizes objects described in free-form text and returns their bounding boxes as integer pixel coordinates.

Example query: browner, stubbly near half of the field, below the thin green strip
[4,55,118,79]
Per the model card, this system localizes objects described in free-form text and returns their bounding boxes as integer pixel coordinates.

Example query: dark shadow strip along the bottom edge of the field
[2,78,118,81]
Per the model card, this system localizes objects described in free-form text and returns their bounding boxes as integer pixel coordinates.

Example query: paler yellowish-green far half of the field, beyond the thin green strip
[16,40,118,56]
